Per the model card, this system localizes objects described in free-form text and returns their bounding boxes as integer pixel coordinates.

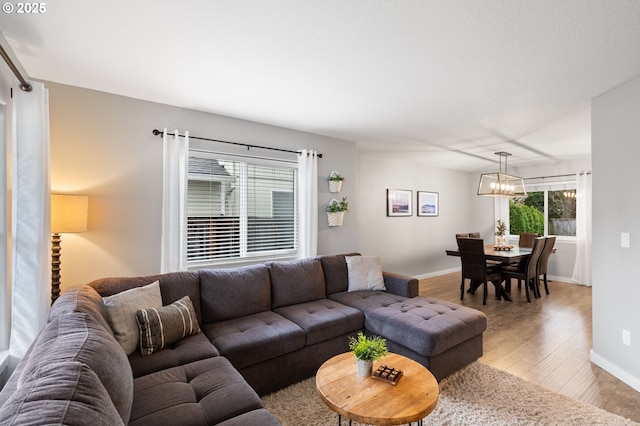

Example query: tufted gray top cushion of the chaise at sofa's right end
[365,297,487,356]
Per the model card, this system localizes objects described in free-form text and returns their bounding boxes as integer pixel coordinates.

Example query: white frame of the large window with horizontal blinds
[185,148,300,270]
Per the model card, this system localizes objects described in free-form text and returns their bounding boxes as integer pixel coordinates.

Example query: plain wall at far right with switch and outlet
[591,73,640,391]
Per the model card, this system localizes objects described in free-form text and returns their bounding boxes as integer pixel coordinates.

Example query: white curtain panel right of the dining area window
[571,172,592,286]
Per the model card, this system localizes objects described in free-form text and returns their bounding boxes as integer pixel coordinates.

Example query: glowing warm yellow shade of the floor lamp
[51,194,89,234]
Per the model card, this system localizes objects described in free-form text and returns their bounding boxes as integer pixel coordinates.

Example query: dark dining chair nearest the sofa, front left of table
[458,237,501,305]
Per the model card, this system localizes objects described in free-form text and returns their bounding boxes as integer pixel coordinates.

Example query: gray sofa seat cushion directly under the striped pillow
[129,333,220,377]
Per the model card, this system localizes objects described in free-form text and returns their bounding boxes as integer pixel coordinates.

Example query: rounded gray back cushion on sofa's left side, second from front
[7,312,133,424]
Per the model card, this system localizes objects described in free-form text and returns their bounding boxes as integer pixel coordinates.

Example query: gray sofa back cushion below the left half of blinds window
[200,265,271,324]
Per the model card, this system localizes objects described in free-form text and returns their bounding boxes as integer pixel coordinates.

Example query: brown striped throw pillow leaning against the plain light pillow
[136,296,200,356]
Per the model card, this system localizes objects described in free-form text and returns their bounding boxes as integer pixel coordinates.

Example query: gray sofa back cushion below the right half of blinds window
[267,259,327,309]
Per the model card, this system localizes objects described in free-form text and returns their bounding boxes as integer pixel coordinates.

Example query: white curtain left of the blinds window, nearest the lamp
[160,129,189,273]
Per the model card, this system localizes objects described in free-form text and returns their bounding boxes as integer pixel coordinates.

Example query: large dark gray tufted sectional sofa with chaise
[0,254,486,426]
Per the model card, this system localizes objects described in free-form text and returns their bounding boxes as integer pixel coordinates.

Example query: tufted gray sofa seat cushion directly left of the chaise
[275,299,364,346]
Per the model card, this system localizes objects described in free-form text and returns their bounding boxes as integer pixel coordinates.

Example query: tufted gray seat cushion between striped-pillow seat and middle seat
[200,311,305,369]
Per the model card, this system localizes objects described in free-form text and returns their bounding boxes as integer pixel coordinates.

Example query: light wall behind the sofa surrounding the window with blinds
[46,83,358,291]
